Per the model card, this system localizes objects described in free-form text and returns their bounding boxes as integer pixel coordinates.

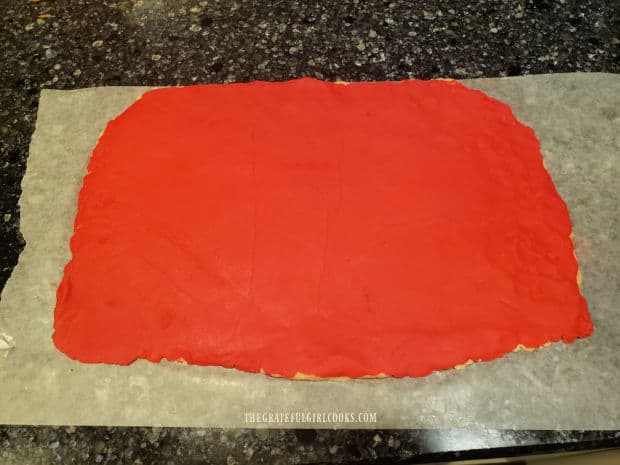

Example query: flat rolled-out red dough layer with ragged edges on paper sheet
[53,79,592,377]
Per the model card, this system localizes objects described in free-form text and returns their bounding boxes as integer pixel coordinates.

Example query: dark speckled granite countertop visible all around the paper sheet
[0,0,620,464]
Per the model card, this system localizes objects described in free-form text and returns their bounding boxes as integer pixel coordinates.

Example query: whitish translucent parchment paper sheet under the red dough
[0,74,620,429]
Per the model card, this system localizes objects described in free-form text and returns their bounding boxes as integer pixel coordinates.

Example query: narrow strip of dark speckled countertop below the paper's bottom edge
[0,426,620,465]
